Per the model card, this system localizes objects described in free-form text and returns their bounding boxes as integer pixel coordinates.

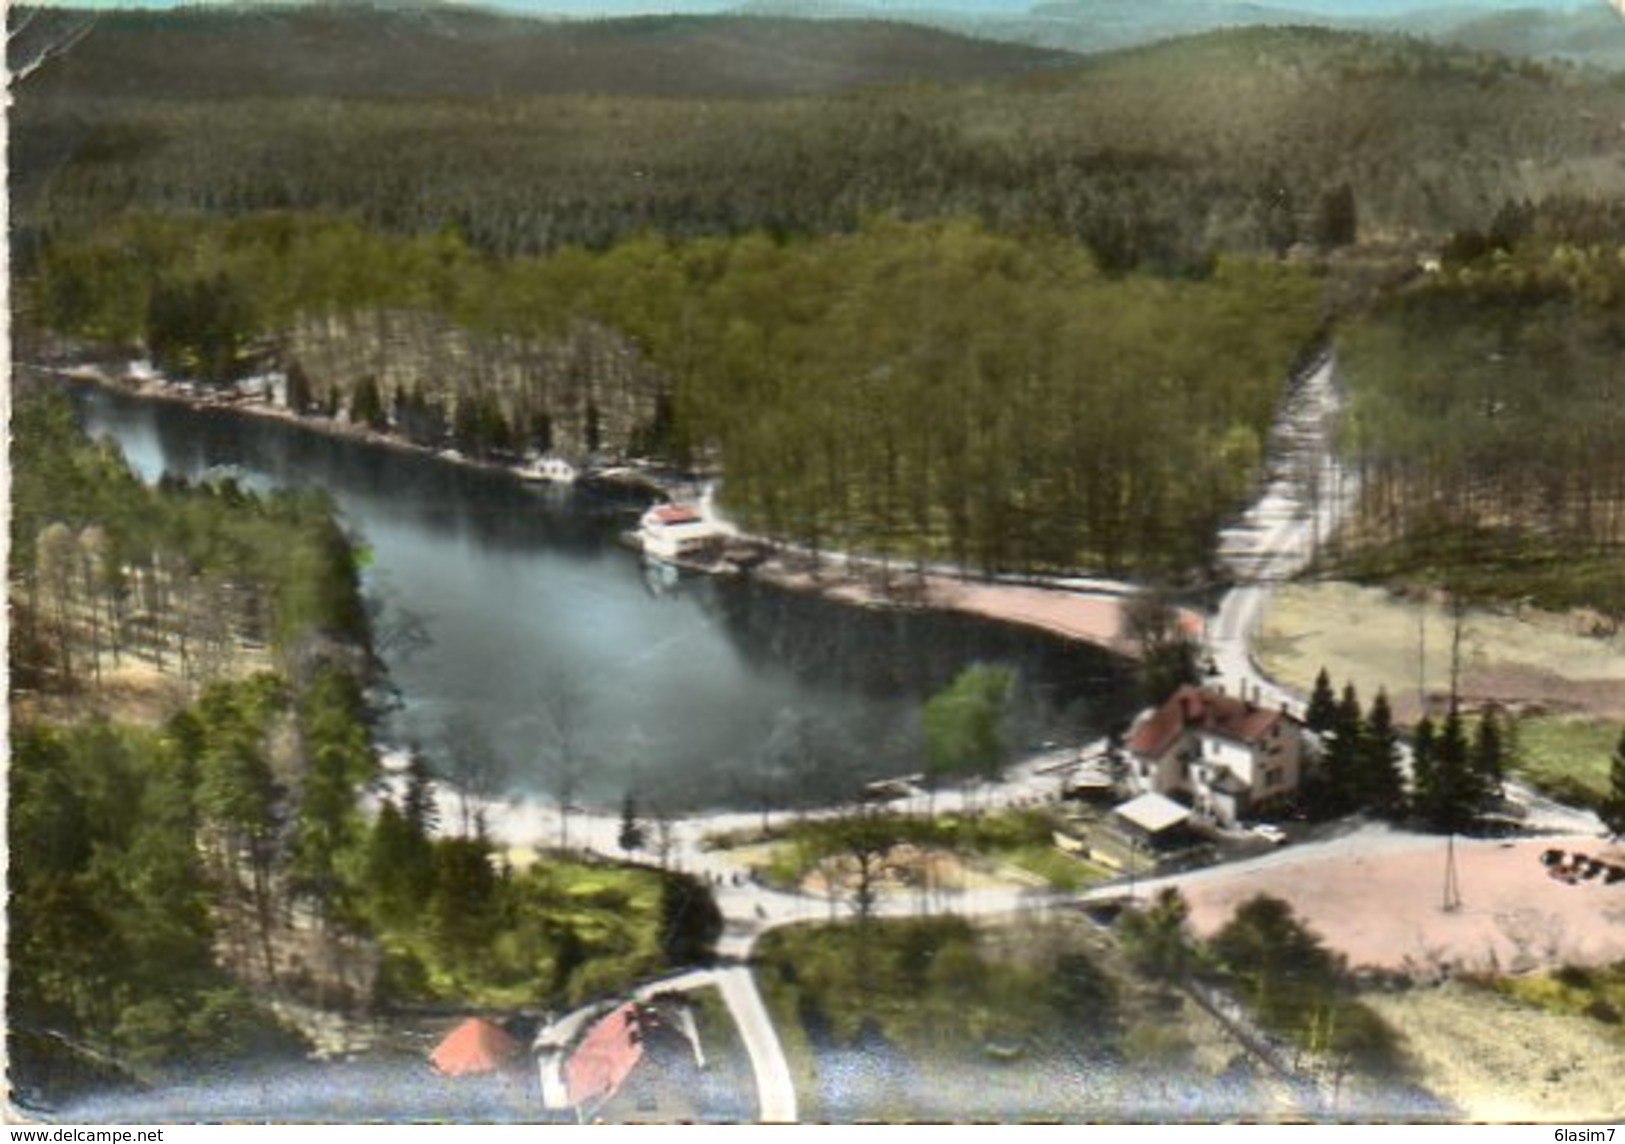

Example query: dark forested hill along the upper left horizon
[13,5,1074,99]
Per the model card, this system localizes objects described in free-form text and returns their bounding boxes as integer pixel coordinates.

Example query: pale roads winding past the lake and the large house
[487,347,1601,1123]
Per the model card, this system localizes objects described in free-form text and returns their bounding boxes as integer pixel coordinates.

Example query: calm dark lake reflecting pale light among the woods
[72,387,1129,809]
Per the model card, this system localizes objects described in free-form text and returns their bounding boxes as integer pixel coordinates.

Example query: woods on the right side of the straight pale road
[1341,202,1625,627]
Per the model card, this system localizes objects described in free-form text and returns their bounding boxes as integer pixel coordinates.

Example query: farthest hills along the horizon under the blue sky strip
[8,0,1625,107]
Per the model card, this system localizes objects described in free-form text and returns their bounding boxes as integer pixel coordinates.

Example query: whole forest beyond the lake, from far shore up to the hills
[15,17,1625,575]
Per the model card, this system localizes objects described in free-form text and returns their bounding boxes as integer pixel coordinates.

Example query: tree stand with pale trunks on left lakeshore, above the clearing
[10,381,367,694]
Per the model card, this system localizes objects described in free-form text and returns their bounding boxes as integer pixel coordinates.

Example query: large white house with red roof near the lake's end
[1125,684,1307,826]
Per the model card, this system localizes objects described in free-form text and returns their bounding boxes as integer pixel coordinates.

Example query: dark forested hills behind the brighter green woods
[10,0,1625,261]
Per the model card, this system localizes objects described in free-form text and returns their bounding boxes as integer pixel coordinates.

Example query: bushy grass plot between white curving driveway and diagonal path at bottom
[756,912,1437,1121]
